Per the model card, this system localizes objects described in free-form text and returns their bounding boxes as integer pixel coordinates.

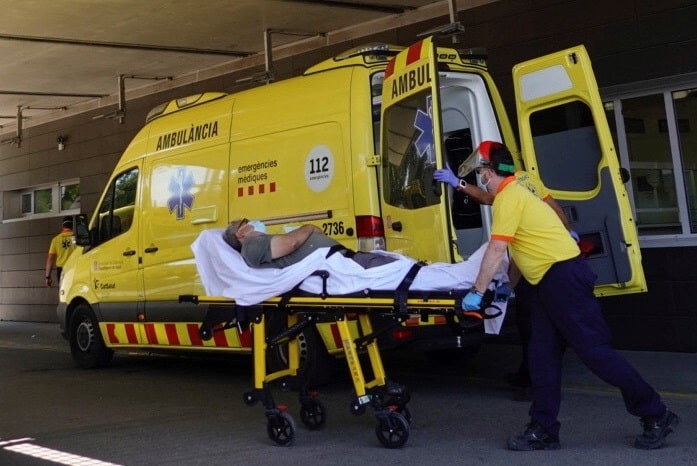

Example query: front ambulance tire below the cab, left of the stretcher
[70,303,114,369]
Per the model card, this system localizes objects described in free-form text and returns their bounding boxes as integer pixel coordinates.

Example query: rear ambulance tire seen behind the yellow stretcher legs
[266,312,336,388]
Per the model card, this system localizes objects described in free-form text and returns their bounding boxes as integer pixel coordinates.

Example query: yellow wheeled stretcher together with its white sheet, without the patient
[179,229,507,448]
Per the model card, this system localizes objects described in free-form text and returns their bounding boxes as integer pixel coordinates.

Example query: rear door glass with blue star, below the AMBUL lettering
[382,90,440,209]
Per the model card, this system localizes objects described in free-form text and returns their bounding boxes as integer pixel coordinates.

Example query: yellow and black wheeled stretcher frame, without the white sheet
[180,278,497,448]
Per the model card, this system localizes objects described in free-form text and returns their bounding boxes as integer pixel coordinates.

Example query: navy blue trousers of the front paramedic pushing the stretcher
[528,257,666,437]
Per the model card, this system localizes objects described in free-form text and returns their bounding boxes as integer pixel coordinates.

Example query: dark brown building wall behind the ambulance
[0,0,697,351]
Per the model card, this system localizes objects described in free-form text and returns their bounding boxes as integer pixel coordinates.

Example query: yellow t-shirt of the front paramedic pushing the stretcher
[491,176,580,285]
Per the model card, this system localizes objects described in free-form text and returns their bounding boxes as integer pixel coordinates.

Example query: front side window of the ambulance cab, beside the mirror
[96,168,138,243]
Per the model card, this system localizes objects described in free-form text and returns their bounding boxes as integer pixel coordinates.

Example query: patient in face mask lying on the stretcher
[223,219,396,269]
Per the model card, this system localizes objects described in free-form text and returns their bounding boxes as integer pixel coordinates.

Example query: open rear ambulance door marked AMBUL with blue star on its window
[380,37,454,262]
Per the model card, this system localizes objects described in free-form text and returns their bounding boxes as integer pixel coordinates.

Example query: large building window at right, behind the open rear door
[605,76,697,246]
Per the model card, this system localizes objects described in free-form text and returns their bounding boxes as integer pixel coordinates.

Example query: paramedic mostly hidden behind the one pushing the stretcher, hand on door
[433,141,579,401]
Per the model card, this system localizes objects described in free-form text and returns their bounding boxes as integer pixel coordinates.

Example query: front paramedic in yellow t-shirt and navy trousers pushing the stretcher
[462,140,679,450]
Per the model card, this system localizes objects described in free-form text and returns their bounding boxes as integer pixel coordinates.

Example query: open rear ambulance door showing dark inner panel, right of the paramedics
[513,46,646,296]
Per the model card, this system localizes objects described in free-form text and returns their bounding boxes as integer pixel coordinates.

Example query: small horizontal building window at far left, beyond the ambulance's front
[2,180,80,221]
